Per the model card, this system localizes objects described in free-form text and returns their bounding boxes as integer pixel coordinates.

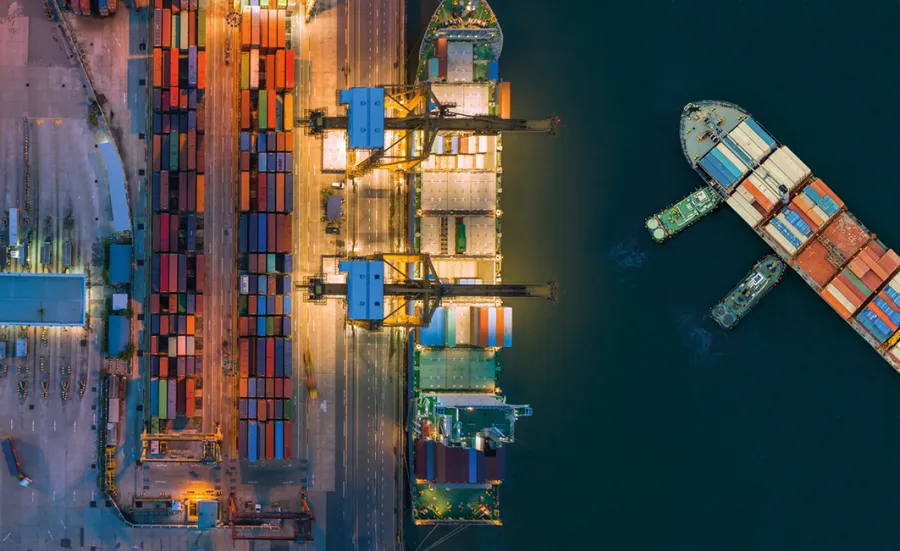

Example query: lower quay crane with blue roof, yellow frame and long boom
[298,253,558,330]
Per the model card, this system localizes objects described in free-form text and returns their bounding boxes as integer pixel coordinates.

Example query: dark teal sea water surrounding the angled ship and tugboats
[409,0,900,551]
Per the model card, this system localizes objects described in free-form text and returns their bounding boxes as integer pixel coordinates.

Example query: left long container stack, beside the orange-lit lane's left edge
[150,0,207,432]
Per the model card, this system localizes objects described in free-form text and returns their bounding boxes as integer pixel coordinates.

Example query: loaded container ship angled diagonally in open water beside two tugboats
[680,101,900,371]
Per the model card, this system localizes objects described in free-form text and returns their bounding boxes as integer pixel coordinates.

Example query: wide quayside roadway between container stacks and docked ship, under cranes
[295,0,402,549]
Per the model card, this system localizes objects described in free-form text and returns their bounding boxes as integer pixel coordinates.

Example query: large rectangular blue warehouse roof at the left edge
[0,273,86,326]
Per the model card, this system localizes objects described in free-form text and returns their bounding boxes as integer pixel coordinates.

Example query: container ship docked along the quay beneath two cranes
[409,0,531,525]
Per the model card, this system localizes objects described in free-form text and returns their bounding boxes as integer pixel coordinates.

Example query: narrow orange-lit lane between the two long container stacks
[203,0,240,457]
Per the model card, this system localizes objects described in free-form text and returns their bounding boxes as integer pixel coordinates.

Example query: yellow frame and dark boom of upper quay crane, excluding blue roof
[297,83,559,178]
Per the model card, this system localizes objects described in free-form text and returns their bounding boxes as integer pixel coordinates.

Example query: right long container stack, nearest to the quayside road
[237,0,294,461]
